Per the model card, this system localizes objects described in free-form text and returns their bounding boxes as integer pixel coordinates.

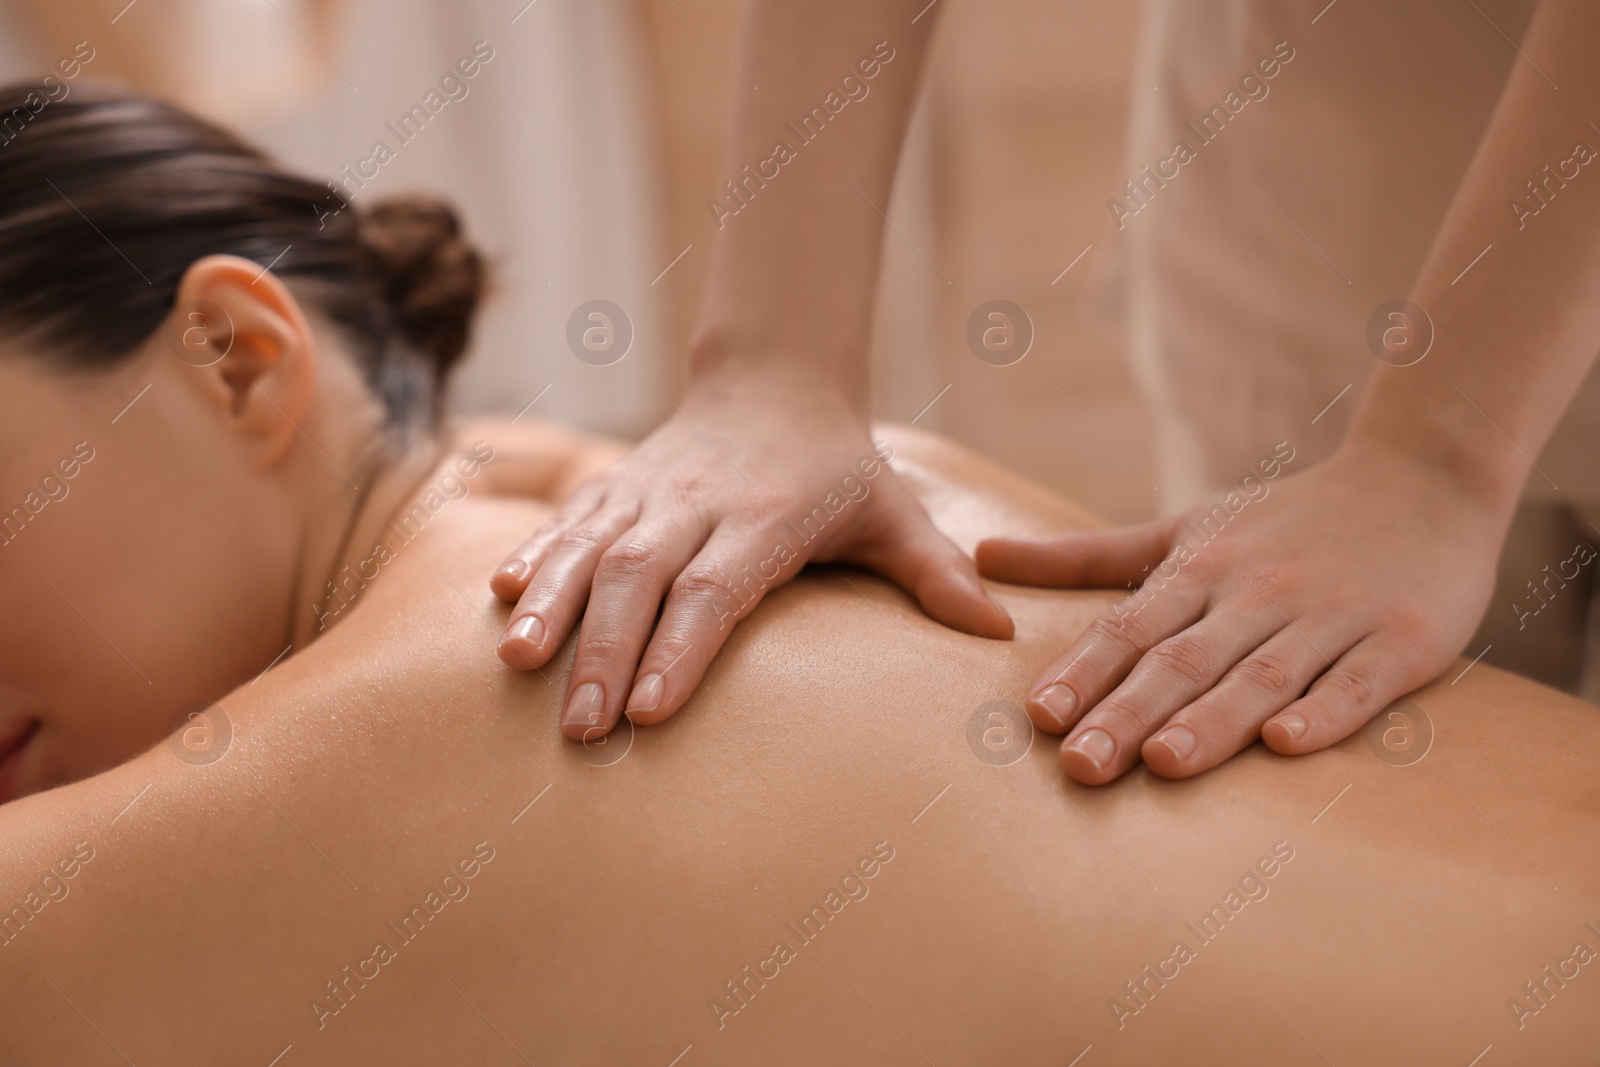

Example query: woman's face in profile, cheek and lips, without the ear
[0,321,302,803]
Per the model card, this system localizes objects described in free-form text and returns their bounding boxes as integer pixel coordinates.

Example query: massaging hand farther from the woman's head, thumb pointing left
[978,448,1510,785]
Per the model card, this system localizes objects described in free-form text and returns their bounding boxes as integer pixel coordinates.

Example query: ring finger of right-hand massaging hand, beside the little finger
[1141,617,1360,777]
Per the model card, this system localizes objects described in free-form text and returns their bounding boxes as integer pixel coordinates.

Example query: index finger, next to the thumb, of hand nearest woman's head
[624,522,805,726]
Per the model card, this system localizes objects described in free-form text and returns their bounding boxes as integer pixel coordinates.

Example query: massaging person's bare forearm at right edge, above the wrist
[1347,0,1600,509]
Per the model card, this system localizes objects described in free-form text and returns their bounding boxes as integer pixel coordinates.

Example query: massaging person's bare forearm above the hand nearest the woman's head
[691,0,938,414]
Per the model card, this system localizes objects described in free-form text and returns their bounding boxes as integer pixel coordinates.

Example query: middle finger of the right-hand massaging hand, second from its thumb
[1061,598,1283,785]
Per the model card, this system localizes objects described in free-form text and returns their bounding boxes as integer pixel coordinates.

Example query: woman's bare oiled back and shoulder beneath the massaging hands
[0,432,1600,1067]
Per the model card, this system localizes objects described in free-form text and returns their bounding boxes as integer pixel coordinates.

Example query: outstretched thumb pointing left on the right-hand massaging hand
[976,520,1176,589]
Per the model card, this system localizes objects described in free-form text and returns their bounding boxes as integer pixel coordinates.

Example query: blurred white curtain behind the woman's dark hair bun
[0,0,670,435]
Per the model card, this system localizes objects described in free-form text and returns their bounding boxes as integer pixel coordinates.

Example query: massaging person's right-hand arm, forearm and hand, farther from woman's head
[978,0,1600,784]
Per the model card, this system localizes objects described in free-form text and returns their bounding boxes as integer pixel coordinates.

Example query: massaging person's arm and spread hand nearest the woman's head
[493,0,1011,737]
